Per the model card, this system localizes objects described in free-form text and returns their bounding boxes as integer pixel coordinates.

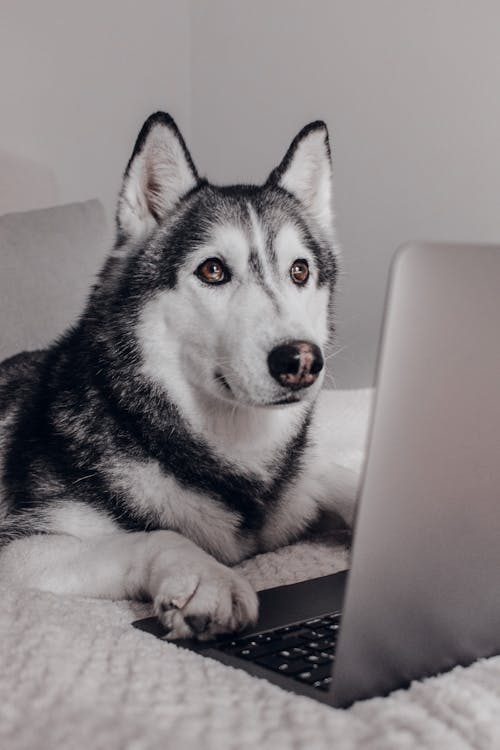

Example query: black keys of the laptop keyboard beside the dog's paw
[217,612,341,690]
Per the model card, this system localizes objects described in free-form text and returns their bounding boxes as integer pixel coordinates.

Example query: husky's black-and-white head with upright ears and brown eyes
[110,113,336,407]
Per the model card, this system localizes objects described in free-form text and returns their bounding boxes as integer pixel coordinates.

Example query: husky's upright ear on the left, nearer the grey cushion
[116,112,199,244]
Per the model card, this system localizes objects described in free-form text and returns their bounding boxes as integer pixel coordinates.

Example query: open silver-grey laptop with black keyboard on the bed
[134,244,500,707]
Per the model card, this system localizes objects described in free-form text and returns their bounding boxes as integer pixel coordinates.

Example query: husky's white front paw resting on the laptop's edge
[154,561,258,640]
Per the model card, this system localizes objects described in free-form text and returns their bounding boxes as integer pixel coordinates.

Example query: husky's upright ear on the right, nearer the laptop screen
[268,120,333,233]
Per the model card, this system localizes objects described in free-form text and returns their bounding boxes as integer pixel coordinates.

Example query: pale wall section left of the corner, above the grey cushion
[0,0,190,235]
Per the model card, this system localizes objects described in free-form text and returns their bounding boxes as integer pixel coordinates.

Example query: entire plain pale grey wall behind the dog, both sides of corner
[0,0,500,386]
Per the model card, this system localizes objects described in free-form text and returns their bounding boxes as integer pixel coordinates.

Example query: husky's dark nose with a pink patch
[267,341,324,391]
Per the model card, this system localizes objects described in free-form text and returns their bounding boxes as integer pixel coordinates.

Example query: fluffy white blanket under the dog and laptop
[0,392,500,750]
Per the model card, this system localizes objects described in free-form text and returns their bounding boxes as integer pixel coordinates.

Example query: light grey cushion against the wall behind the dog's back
[0,200,107,361]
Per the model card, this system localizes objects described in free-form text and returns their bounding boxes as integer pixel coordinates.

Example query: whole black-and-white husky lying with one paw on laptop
[0,112,355,639]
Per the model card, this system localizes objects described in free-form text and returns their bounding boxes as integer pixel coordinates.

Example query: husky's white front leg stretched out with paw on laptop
[0,531,258,638]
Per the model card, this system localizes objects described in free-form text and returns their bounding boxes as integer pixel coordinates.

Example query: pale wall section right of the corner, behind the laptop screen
[191,0,500,385]
